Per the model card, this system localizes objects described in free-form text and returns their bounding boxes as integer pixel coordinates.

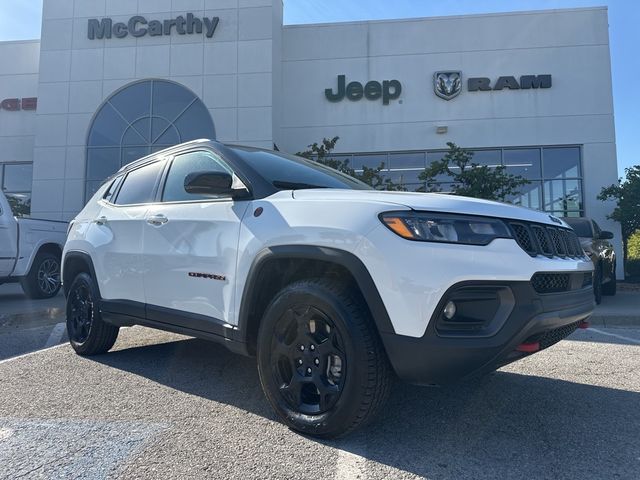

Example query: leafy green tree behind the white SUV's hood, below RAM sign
[419,142,529,202]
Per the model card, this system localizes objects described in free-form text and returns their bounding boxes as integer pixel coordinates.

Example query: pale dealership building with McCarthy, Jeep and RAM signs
[0,0,621,271]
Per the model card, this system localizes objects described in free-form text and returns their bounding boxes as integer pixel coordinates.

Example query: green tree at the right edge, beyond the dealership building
[598,165,640,261]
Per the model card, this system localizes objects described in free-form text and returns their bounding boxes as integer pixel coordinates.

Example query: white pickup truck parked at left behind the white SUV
[0,191,67,298]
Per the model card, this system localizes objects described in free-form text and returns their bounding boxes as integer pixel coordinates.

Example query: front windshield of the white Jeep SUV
[229,147,372,190]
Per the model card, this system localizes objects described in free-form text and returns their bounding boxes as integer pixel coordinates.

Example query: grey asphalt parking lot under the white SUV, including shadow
[0,320,640,479]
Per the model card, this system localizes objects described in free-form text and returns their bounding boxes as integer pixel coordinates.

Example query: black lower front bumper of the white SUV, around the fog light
[381,281,595,385]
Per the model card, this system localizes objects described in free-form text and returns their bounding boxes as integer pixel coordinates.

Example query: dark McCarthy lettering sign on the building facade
[87,13,220,40]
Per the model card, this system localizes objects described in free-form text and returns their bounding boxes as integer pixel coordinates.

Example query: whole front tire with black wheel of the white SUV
[257,279,392,438]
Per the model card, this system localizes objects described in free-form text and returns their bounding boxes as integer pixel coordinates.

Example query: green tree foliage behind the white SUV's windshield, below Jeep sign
[296,137,406,190]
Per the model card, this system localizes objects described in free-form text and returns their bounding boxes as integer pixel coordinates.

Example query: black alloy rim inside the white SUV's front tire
[271,305,347,415]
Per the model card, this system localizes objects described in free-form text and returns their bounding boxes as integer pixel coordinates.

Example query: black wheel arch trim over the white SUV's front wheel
[238,245,395,342]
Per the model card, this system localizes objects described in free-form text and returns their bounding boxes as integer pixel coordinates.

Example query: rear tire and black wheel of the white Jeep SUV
[67,272,120,356]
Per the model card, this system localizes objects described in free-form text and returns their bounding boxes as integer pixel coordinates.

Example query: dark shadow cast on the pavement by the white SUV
[94,340,640,479]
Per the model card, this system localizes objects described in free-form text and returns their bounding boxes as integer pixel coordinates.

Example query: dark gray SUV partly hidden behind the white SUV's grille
[563,217,616,304]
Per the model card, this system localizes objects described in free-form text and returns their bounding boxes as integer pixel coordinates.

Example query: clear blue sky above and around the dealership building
[0,0,640,175]
